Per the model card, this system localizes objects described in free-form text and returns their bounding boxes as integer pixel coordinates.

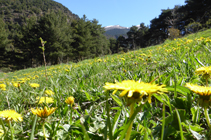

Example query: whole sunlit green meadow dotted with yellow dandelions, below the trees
[0,30,211,140]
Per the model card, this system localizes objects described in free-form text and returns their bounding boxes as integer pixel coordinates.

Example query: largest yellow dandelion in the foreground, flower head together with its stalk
[104,80,167,140]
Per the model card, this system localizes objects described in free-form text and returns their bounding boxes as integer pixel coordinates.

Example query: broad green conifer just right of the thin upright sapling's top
[37,12,72,64]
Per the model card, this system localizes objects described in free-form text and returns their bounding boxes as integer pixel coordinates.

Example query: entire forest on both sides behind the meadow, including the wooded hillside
[0,0,211,72]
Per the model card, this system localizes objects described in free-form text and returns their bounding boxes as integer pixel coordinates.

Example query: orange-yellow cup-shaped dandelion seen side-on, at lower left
[31,106,57,118]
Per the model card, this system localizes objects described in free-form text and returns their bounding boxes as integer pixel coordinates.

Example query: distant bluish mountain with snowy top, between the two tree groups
[104,25,139,39]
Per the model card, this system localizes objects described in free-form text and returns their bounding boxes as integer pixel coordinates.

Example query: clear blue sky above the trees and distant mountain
[54,0,185,27]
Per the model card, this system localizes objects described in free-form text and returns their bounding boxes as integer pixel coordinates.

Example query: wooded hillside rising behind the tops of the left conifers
[0,0,79,28]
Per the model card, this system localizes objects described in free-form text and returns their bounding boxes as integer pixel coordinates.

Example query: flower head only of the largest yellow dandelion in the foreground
[104,80,167,103]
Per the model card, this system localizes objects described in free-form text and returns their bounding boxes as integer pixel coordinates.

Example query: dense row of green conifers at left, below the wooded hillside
[0,12,110,69]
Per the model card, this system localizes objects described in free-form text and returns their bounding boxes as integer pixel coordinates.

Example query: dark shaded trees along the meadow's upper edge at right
[113,0,211,52]
